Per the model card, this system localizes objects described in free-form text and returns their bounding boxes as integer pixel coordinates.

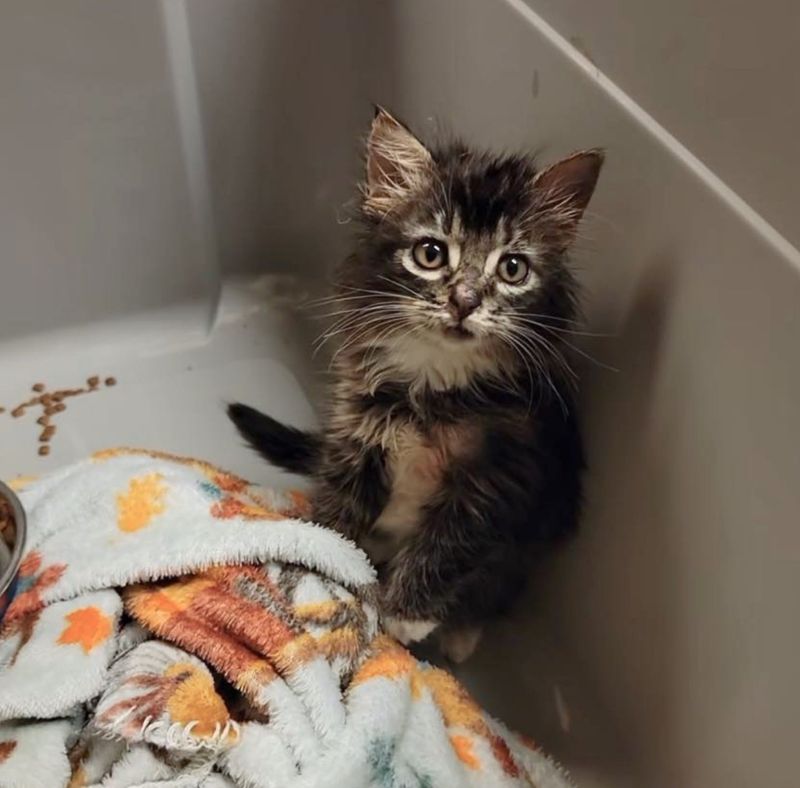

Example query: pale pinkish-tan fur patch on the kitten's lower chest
[364,419,480,563]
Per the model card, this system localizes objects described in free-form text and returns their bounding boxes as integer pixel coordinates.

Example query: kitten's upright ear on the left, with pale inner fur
[364,107,433,216]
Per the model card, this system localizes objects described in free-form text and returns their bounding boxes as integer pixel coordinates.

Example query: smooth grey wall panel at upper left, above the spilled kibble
[0,0,216,337]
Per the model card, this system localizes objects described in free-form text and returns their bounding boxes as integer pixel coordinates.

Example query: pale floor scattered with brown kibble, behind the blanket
[0,279,314,483]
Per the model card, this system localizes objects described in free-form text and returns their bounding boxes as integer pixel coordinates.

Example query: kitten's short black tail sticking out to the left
[228,402,322,476]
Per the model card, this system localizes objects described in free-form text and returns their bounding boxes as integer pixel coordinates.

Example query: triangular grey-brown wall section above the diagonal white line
[526,0,800,246]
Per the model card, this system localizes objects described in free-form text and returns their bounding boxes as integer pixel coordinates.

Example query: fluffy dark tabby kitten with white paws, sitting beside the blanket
[229,110,603,661]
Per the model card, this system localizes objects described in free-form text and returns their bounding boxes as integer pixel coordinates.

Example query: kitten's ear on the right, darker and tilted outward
[533,149,605,248]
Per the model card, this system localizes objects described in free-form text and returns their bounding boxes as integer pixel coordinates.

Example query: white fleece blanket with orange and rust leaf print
[0,450,569,788]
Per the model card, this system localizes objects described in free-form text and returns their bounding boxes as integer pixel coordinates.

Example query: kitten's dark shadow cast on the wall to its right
[538,254,682,768]
